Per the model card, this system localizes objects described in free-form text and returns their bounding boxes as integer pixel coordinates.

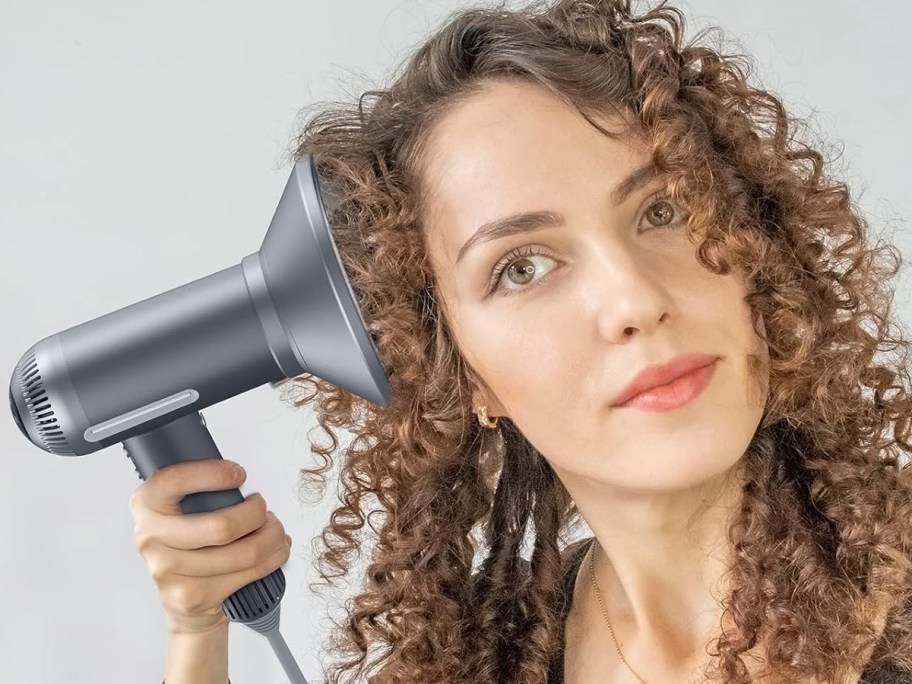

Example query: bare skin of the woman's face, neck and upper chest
[422,77,780,684]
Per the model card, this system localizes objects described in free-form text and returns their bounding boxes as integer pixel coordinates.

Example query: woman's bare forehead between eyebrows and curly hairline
[422,83,648,264]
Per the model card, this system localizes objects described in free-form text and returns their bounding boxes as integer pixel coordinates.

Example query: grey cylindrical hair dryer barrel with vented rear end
[11,254,294,456]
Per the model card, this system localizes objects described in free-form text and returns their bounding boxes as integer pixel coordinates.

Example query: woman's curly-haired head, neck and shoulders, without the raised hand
[137,0,912,684]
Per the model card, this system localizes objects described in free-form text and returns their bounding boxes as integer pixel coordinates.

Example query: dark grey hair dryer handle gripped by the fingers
[123,411,285,623]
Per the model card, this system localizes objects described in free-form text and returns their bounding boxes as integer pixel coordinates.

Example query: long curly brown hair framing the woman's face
[273,0,912,684]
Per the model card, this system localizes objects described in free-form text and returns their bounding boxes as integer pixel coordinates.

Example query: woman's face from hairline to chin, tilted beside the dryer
[423,83,768,492]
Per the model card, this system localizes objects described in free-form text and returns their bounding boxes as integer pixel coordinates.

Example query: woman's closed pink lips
[611,354,719,411]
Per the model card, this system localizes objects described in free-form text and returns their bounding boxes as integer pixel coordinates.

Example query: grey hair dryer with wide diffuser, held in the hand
[9,155,390,684]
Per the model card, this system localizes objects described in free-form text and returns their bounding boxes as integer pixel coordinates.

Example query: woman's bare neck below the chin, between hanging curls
[574,473,741,664]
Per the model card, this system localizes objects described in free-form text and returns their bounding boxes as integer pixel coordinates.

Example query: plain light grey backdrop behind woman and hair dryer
[0,0,912,684]
